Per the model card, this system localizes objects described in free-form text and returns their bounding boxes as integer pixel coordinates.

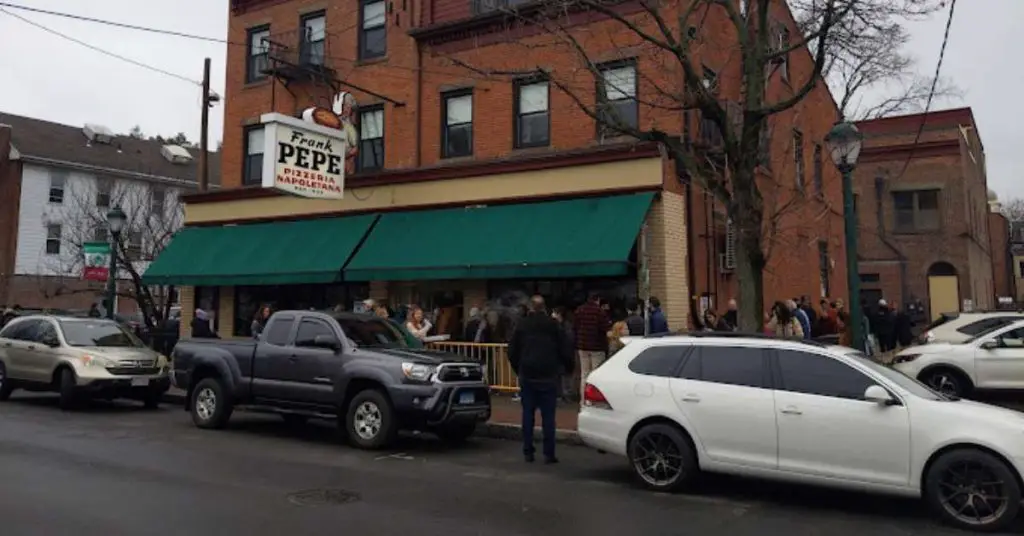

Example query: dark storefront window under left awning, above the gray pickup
[233,283,370,337]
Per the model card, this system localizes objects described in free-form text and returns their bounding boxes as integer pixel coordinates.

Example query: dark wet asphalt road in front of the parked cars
[0,395,1021,536]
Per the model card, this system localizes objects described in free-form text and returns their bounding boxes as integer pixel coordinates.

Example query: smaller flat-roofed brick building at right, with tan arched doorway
[855,108,997,318]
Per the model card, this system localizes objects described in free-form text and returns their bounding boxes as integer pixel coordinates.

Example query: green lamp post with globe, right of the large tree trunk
[825,121,864,351]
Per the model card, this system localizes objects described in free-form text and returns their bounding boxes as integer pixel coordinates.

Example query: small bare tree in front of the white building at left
[41,179,184,328]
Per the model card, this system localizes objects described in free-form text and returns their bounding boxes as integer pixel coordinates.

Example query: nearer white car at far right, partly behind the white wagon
[893,319,1024,397]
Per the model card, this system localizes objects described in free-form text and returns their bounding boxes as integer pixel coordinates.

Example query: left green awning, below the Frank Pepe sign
[142,214,378,286]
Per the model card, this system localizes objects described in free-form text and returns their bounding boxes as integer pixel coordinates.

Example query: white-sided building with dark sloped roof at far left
[0,113,219,313]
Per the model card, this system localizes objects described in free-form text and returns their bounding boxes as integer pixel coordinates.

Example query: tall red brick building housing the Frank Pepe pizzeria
[147,0,846,335]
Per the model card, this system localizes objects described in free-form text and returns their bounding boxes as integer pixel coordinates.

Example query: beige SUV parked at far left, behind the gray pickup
[0,315,170,409]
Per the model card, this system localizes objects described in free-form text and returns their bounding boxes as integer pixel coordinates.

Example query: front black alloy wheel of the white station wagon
[938,461,1010,527]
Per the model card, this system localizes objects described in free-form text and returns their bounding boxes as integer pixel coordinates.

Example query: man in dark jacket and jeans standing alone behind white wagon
[509,295,573,463]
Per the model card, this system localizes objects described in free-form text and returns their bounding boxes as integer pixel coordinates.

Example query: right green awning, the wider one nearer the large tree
[345,193,654,281]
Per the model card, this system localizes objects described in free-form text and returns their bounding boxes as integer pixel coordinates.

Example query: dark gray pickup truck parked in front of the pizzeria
[172,311,490,449]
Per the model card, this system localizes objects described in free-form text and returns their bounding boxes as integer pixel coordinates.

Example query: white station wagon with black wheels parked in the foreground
[579,333,1024,530]
